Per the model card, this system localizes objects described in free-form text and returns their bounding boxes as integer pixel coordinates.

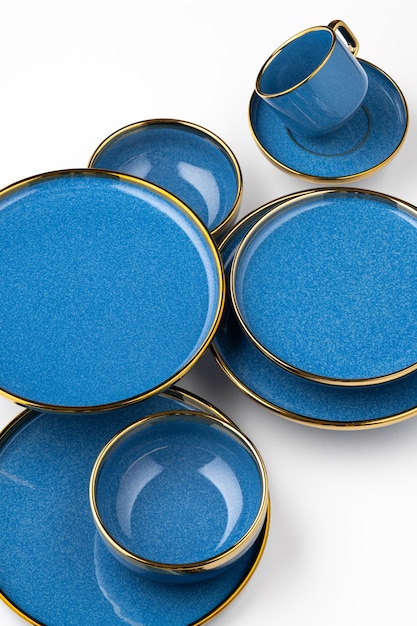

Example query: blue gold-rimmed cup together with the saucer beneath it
[249,20,408,182]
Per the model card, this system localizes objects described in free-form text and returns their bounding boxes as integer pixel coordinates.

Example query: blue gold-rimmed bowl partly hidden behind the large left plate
[89,120,241,233]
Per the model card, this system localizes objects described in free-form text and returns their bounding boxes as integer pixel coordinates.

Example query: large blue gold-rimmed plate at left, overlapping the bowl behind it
[0,169,224,410]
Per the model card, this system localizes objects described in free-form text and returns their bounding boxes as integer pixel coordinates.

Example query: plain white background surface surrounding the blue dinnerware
[0,0,417,626]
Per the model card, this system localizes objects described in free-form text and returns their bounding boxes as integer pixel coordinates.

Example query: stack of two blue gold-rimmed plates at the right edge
[212,188,417,428]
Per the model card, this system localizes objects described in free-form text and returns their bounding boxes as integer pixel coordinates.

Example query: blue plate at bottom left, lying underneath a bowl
[0,389,266,626]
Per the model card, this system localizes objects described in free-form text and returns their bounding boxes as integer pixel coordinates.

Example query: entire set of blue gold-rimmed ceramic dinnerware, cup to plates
[0,20,417,626]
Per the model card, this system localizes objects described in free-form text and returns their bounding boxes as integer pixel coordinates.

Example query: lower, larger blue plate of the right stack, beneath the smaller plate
[212,194,417,429]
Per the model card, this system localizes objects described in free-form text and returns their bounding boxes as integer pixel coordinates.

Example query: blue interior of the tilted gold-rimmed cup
[260,29,334,95]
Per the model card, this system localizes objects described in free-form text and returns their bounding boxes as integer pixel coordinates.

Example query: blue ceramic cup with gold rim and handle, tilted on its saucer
[255,20,368,137]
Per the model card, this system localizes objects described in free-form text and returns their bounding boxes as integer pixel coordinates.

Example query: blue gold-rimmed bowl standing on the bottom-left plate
[90,411,268,583]
